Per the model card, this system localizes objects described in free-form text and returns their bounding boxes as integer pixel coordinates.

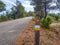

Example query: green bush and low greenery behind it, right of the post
[40,14,60,28]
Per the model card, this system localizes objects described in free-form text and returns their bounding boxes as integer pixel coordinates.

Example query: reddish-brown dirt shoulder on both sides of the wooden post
[15,22,60,45]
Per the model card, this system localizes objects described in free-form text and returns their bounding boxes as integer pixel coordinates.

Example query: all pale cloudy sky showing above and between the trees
[2,0,60,13]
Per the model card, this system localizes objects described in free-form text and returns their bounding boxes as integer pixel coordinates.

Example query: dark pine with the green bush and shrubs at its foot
[31,0,60,28]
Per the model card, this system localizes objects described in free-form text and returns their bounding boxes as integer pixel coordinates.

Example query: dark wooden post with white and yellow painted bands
[35,14,40,45]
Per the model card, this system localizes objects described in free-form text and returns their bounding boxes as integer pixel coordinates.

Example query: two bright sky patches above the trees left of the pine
[2,0,34,12]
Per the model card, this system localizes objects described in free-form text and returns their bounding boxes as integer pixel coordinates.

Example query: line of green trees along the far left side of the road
[0,0,34,22]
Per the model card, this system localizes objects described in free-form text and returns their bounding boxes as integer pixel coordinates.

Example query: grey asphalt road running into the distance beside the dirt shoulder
[0,17,32,45]
